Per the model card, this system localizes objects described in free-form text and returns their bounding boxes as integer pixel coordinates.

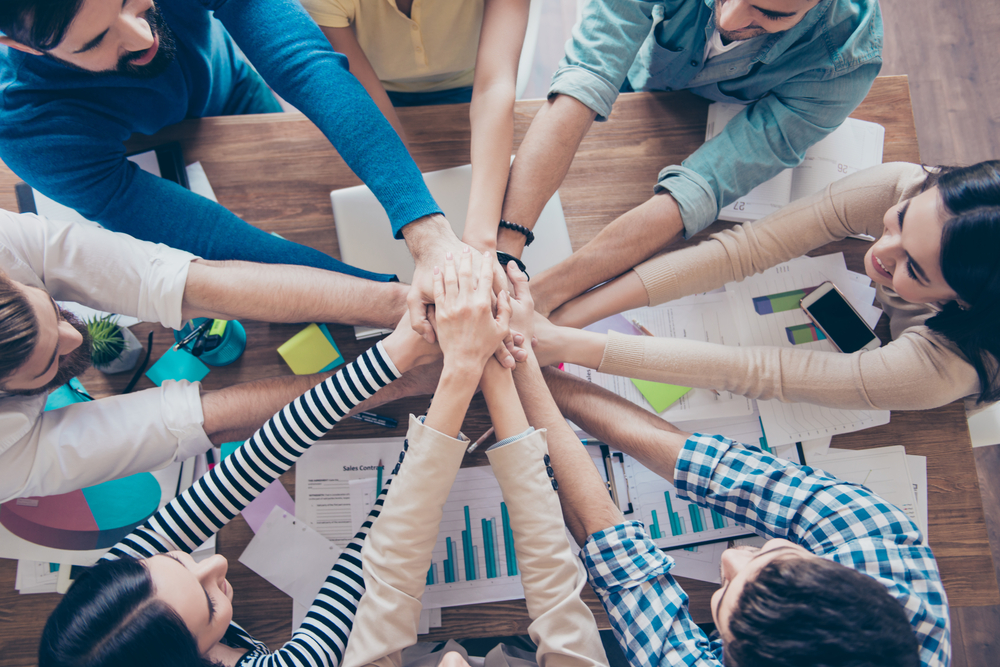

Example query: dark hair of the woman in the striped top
[38,557,216,667]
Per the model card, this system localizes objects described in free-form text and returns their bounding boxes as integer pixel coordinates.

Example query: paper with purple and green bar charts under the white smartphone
[726,257,889,447]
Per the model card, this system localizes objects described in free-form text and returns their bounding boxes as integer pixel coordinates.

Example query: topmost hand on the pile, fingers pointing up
[432,246,510,373]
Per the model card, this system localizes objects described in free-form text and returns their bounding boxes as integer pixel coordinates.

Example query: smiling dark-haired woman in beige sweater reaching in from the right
[535,161,1000,410]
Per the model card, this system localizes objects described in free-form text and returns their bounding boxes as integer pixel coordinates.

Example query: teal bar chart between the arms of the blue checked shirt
[623,448,752,549]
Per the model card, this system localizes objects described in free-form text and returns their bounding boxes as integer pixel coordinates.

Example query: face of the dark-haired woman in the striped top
[143,551,233,654]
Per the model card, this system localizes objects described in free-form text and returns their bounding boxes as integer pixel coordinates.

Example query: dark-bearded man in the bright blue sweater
[0,0,460,298]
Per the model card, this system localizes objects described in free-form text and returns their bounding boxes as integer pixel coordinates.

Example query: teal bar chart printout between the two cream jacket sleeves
[351,467,524,609]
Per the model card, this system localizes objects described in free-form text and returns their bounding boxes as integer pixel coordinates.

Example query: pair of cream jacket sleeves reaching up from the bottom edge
[342,415,608,667]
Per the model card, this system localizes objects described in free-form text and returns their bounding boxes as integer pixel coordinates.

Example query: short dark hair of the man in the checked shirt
[724,558,920,667]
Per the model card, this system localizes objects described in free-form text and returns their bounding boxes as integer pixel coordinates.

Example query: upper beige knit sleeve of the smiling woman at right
[634,162,926,306]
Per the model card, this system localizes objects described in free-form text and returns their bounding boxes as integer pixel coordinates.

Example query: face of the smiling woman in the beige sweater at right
[865,187,958,303]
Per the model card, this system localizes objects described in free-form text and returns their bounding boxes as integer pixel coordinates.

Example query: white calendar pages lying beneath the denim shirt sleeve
[705,102,885,222]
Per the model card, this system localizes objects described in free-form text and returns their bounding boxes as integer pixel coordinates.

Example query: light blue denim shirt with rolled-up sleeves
[549,0,882,237]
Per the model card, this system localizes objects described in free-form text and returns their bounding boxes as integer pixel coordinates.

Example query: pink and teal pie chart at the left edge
[0,472,160,551]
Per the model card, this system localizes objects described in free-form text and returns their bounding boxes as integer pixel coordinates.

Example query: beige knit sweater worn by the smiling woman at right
[598,162,979,410]
